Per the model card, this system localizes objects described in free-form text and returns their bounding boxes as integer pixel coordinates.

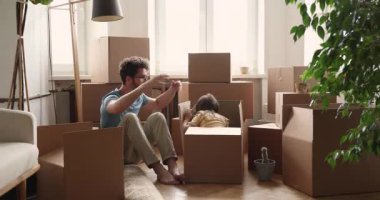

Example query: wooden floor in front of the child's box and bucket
[140,156,380,200]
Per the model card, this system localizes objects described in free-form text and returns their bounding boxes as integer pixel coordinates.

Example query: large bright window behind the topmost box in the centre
[151,0,257,74]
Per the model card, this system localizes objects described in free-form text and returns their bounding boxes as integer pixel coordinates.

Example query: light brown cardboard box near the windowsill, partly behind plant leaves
[268,66,316,114]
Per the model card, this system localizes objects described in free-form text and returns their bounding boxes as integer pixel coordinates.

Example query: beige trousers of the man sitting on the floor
[122,112,177,167]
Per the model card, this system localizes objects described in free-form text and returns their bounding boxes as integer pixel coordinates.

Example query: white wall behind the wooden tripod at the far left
[0,1,54,124]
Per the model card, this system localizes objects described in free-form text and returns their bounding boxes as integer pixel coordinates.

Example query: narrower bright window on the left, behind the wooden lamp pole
[49,0,87,76]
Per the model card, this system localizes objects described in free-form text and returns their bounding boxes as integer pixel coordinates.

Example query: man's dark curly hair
[119,56,149,85]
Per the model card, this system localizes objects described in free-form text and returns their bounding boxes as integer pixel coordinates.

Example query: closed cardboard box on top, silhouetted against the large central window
[188,53,231,83]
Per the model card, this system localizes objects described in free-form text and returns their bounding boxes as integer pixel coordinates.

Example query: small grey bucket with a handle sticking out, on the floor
[253,147,276,181]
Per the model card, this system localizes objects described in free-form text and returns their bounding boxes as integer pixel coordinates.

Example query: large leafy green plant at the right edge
[285,0,380,167]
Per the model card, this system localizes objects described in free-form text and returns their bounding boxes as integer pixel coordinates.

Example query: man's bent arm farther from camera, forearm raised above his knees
[145,81,182,110]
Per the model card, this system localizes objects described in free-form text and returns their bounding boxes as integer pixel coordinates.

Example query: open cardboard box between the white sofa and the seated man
[37,122,124,200]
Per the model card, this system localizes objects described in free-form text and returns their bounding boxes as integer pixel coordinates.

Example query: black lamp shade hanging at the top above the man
[92,0,123,22]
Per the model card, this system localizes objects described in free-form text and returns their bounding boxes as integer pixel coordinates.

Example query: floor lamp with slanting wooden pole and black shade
[64,0,123,122]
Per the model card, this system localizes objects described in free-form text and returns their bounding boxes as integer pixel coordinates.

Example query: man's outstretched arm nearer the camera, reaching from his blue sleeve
[107,75,168,114]
